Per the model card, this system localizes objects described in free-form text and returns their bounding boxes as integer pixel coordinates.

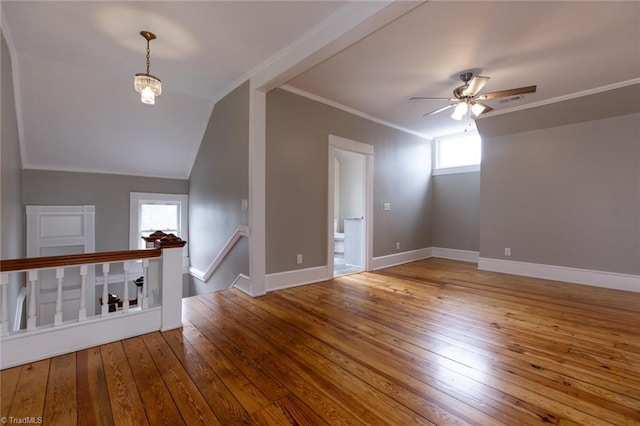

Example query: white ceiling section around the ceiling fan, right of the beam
[289,1,640,138]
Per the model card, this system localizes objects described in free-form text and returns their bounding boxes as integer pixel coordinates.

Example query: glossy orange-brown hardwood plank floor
[0,259,640,425]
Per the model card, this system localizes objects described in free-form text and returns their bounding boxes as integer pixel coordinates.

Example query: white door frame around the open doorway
[327,134,374,278]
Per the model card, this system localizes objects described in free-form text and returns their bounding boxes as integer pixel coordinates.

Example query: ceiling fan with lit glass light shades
[411,72,536,120]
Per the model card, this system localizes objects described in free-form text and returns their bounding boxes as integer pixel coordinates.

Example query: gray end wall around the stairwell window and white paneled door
[23,170,189,252]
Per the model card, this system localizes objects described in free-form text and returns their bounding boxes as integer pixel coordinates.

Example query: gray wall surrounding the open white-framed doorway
[266,89,431,273]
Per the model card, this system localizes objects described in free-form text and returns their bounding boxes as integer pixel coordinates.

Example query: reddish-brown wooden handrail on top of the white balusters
[0,248,162,272]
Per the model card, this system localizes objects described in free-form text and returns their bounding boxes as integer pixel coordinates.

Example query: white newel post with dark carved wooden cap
[154,234,187,331]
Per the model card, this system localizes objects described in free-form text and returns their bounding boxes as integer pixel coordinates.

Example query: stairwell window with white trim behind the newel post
[129,192,189,257]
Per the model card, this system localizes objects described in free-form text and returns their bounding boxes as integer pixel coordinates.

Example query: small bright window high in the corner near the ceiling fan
[433,133,482,175]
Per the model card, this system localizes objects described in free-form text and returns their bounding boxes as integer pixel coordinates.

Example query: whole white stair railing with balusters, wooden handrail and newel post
[0,234,186,368]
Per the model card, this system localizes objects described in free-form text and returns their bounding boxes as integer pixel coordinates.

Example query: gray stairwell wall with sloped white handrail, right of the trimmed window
[189,82,249,294]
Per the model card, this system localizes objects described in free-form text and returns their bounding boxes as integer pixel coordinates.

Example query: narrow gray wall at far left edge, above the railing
[0,30,25,327]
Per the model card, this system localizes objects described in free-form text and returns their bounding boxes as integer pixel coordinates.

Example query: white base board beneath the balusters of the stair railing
[0,307,162,369]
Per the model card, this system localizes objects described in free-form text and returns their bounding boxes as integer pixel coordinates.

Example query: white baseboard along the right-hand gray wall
[478,257,640,293]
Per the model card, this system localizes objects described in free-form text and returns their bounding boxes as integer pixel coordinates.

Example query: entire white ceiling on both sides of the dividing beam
[2,0,640,178]
